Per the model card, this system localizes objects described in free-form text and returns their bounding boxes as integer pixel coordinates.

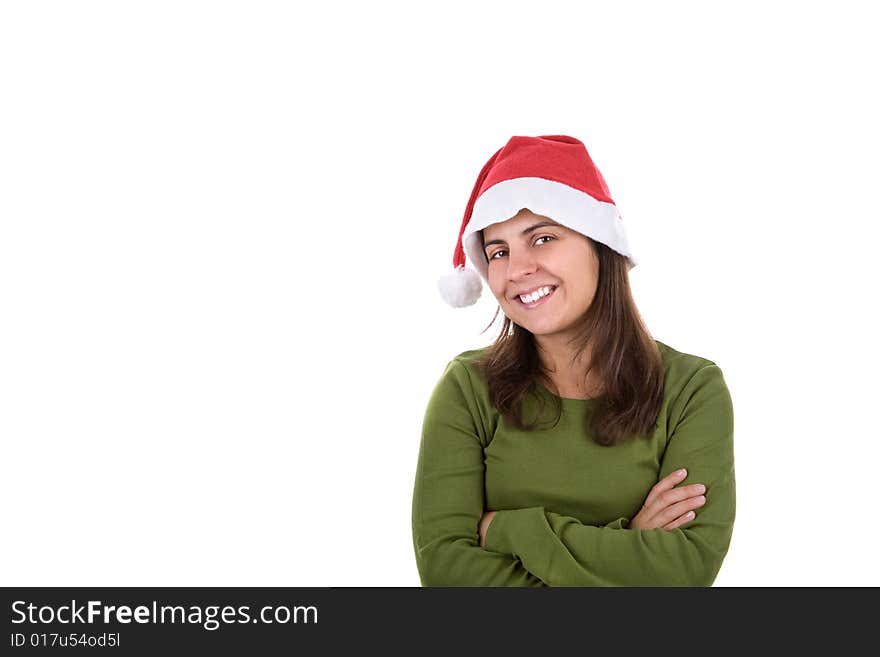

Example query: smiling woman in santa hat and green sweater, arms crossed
[412,136,735,586]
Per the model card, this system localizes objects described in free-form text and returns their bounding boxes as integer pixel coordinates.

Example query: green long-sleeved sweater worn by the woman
[412,341,736,586]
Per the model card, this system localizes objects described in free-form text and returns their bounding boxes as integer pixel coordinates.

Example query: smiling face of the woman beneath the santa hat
[483,209,599,340]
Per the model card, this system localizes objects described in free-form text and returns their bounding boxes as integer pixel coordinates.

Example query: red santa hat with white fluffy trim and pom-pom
[438,135,636,308]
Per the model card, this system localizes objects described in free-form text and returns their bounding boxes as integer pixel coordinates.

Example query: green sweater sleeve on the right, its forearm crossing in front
[486,364,736,586]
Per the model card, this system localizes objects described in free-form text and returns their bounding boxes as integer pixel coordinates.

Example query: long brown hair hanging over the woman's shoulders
[476,239,664,446]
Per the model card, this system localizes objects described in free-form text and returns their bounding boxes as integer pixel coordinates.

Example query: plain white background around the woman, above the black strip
[0,0,880,586]
